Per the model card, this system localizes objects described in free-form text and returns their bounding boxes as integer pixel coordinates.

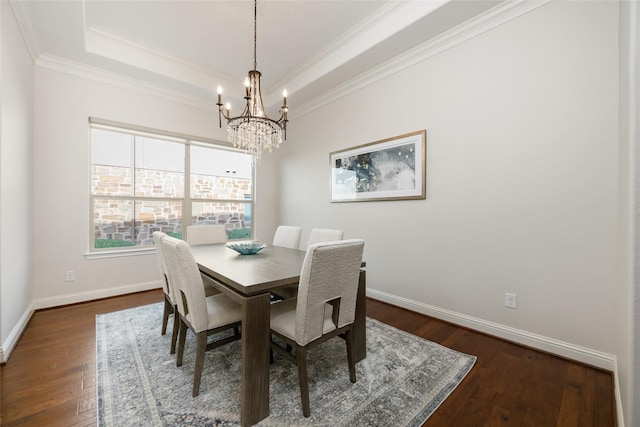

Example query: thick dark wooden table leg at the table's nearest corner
[240,294,270,427]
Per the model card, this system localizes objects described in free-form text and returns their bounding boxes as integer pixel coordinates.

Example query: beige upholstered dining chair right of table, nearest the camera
[271,239,364,417]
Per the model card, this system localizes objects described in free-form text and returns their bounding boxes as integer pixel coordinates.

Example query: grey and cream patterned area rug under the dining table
[96,304,476,427]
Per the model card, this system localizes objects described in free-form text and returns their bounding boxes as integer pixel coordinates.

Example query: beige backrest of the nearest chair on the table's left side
[162,236,209,333]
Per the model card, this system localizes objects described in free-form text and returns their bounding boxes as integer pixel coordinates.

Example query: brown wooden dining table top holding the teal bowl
[191,243,306,296]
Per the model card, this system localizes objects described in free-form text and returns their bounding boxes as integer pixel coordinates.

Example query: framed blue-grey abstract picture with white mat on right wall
[329,129,427,202]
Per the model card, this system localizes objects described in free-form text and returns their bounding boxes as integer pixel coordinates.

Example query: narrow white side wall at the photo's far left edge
[0,1,34,362]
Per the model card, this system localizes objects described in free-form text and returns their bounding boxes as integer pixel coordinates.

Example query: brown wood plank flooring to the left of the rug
[0,290,163,427]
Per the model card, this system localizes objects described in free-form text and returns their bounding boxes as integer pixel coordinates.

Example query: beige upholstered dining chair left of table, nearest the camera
[162,236,242,397]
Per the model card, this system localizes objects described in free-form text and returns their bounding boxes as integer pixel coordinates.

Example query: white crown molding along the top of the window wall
[36,54,217,110]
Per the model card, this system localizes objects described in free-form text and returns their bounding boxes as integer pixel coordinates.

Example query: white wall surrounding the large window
[33,67,274,308]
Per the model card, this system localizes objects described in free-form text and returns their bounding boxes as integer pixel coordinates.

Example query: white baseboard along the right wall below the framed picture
[367,289,617,372]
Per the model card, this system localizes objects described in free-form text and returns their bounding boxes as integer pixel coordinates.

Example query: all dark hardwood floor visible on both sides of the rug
[0,290,615,427]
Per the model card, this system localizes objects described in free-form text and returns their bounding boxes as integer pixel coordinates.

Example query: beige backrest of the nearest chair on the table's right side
[295,239,364,345]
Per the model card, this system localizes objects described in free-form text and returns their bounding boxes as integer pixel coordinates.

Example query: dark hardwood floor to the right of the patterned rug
[367,300,616,427]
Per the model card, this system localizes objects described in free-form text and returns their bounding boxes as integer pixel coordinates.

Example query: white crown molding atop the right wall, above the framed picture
[289,0,552,119]
